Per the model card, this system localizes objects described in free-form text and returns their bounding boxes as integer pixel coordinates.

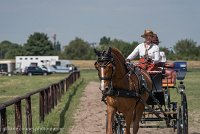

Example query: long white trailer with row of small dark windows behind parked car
[15,56,59,73]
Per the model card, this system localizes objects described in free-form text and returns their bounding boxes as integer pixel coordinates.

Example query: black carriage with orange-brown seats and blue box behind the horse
[140,62,188,134]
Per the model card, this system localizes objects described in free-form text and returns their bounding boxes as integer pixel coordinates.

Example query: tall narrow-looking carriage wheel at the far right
[177,93,188,134]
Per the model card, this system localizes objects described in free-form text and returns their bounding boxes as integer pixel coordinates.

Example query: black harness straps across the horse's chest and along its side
[100,63,169,121]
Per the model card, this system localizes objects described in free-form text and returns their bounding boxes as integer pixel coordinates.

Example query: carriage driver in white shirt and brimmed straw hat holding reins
[126,30,160,71]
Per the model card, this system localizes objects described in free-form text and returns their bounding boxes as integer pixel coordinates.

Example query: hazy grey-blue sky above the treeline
[0,0,200,47]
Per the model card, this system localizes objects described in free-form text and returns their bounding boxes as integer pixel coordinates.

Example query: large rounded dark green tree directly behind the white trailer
[24,32,54,56]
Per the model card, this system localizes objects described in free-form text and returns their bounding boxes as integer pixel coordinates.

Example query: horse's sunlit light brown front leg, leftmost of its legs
[106,105,116,134]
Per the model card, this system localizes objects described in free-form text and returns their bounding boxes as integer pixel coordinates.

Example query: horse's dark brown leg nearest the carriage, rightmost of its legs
[133,103,144,134]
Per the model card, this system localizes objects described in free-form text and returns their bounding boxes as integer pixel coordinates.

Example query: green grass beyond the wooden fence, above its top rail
[0,74,68,103]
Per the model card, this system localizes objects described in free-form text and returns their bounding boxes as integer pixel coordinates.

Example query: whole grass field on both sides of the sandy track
[0,69,200,134]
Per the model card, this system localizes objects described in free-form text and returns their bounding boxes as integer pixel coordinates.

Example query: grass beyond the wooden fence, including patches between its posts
[0,74,73,134]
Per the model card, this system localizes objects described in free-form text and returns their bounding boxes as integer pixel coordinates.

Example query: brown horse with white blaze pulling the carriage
[95,48,152,134]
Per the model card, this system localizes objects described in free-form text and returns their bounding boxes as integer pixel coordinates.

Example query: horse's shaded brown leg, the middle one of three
[125,110,133,134]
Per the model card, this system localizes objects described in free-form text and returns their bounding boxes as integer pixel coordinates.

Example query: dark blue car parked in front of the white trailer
[24,66,49,76]
